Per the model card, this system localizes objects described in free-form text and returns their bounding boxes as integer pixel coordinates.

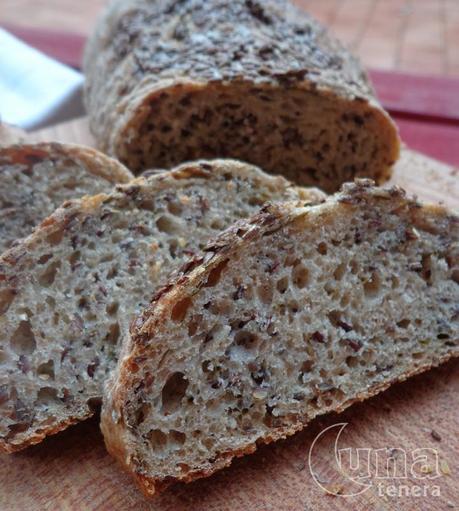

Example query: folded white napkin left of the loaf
[0,29,84,130]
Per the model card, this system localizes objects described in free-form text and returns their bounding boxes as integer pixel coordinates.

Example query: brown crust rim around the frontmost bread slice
[101,180,459,497]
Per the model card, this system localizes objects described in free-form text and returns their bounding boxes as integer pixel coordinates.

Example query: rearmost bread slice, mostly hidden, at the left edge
[0,143,133,253]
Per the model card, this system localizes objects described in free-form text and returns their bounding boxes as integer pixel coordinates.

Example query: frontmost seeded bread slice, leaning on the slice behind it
[102,181,459,495]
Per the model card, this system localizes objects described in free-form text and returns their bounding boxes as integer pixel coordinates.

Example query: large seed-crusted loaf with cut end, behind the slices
[84,0,399,191]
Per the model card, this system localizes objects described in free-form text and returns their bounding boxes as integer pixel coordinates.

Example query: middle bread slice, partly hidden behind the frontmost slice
[0,161,323,452]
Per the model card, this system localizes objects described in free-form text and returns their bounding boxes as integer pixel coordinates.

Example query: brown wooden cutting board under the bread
[0,119,459,511]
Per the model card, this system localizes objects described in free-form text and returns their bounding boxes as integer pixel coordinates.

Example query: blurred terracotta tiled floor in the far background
[0,0,459,76]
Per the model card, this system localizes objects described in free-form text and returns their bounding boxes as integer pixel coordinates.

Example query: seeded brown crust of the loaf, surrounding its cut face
[84,0,399,191]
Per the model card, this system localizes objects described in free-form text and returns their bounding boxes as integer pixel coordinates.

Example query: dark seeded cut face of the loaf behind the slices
[114,81,400,192]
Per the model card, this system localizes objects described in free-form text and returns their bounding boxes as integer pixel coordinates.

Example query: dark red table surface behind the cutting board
[4,26,459,165]
